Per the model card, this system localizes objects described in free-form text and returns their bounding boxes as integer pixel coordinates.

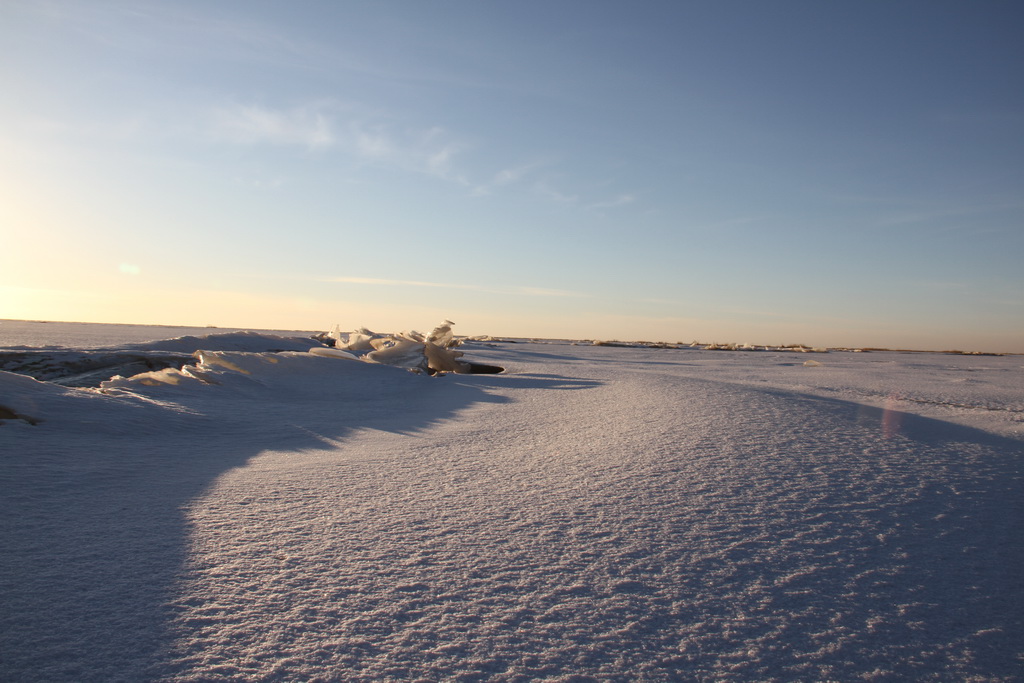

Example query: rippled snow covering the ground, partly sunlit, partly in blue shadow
[0,327,1024,681]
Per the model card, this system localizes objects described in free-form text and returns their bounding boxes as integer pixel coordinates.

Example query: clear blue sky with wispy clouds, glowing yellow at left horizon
[0,0,1024,352]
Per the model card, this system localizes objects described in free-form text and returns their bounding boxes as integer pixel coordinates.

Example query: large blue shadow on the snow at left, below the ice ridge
[0,360,598,681]
